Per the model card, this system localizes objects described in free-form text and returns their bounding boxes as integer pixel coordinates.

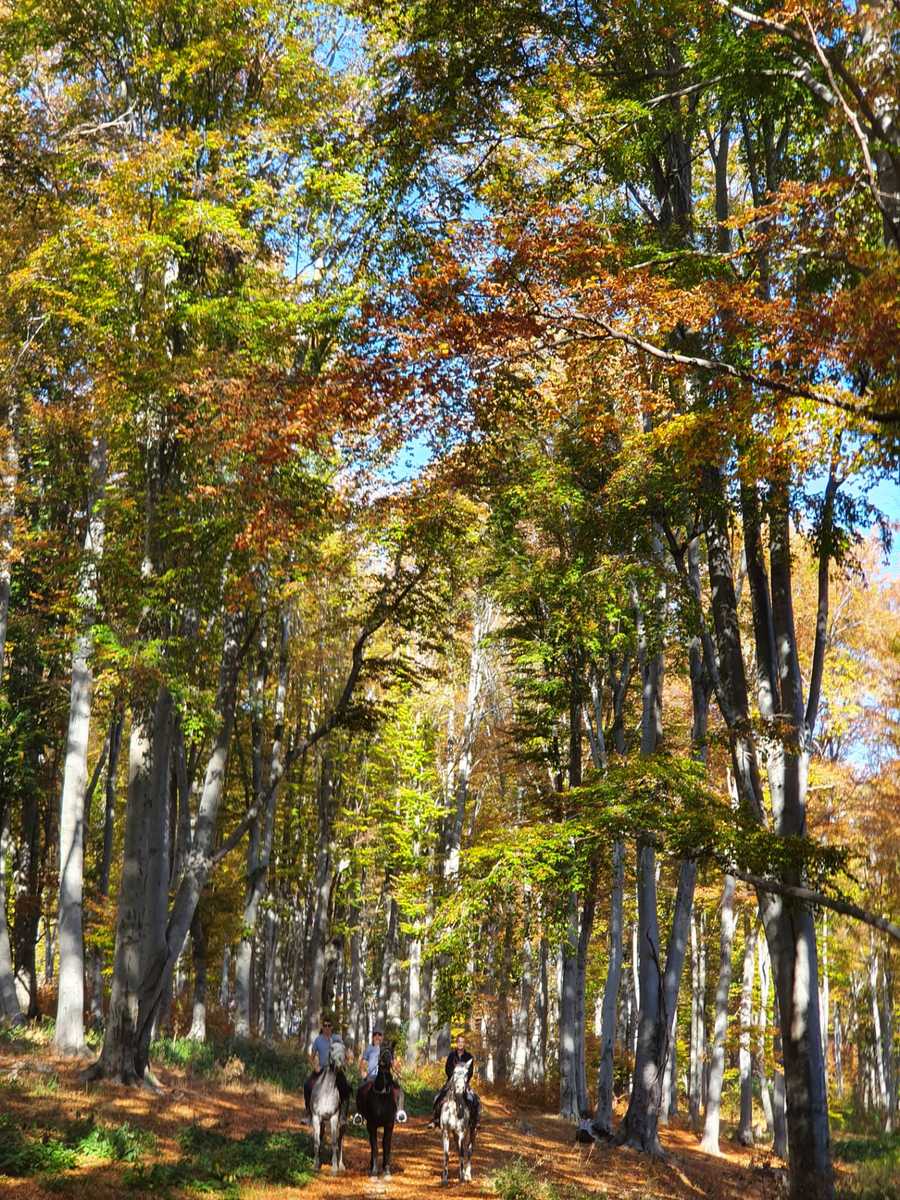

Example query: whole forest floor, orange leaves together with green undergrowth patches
[0,1040,897,1200]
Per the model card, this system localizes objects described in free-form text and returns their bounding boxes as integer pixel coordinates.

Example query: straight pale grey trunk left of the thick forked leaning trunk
[54,438,107,1055]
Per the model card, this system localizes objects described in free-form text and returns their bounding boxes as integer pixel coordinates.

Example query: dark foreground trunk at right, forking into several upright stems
[704,467,838,1200]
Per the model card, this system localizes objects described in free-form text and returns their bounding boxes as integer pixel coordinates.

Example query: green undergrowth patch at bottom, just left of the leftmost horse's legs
[124,1126,313,1200]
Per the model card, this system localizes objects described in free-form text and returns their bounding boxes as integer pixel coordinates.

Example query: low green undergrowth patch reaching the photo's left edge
[0,1115,156,1177]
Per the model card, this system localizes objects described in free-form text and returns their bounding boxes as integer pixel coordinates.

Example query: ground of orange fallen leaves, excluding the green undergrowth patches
[0,1046,775,1200]
